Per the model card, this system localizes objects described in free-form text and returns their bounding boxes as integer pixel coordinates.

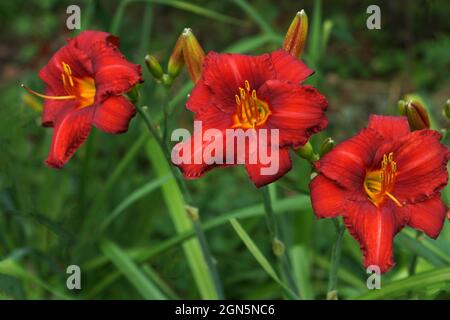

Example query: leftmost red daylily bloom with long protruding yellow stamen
[23,31,143,168]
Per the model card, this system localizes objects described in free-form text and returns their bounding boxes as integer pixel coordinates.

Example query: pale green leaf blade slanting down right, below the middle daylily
[230,218,298,299]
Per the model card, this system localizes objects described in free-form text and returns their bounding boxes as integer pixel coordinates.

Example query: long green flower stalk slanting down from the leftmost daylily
[136,104,224,299]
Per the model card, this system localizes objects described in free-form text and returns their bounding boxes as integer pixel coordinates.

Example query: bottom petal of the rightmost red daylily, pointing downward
[344,201,404,273]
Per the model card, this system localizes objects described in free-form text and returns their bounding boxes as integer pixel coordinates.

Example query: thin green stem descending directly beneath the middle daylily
[260,186,299,296]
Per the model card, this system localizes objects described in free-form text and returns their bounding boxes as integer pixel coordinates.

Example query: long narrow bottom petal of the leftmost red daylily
[45,107,95,168]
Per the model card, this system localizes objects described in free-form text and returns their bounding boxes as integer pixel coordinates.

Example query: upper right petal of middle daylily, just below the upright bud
[271,49,314,84]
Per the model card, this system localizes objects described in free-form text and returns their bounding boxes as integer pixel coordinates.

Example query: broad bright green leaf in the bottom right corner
[357,267,450,300]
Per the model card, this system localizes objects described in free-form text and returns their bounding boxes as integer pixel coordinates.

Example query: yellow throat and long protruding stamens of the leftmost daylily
[22,61,95,108]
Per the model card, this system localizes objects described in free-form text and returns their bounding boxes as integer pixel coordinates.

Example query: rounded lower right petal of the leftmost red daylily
[94,96,136,134]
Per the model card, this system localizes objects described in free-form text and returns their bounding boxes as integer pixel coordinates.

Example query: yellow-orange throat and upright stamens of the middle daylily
[233,80,272,129]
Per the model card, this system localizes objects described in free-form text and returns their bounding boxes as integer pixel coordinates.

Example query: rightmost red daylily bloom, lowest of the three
[310,115,450,272]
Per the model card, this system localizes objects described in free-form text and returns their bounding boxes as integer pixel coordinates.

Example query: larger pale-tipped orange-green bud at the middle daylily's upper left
[181,28,205,83]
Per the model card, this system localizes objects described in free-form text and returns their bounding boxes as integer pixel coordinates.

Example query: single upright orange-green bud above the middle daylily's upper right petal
[283,10,308,58]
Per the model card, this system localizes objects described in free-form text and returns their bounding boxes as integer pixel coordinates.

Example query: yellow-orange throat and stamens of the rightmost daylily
[364,152,402,207]
